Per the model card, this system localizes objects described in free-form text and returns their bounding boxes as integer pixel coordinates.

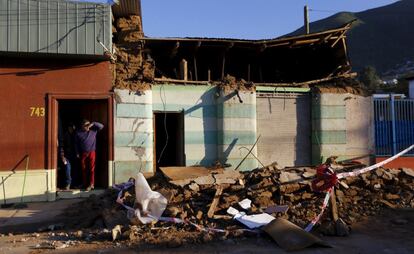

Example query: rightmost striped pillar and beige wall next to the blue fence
[312,93,374,164]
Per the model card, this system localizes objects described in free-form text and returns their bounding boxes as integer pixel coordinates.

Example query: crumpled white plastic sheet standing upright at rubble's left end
[135,173,168,224]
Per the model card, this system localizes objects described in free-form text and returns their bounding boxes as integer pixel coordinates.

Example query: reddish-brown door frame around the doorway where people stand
[46,93,114,188]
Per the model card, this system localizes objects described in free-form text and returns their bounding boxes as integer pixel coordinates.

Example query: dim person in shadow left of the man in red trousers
[59,123,75,190]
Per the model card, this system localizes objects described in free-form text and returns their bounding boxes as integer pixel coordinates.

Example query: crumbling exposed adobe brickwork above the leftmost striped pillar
[113,15,155,91]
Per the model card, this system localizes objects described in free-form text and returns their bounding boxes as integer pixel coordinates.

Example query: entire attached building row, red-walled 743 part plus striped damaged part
[0,0,374,202]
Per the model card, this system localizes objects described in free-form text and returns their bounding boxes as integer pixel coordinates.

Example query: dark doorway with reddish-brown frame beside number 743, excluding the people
[48,94,113,189]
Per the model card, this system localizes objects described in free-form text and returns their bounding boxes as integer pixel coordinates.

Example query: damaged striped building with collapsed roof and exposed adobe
[114,8,374,182]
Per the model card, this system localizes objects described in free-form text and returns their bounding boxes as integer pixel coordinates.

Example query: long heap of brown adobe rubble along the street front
[59,165,414,244]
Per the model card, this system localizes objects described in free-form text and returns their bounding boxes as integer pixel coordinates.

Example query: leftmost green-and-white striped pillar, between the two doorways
[112,89,153,183]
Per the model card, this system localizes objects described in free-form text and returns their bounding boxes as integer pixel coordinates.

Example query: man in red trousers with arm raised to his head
[75,119,104,191]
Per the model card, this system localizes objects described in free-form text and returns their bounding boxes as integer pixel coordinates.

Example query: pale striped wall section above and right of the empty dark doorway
[152,84,217,166]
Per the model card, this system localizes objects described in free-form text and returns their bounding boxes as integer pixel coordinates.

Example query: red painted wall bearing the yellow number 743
[0,57,112,171]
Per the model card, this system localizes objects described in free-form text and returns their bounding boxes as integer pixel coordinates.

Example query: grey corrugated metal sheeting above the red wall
[0,0,112,56]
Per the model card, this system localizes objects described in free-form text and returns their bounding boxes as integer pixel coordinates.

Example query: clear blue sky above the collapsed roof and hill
[141,0,396,39]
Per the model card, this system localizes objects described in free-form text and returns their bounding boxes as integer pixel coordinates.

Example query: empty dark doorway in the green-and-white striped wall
[154,112,185,170]
